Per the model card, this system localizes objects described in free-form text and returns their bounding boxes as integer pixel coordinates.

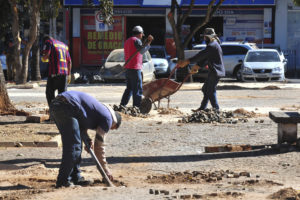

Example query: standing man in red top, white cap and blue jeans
[120,26,153,108]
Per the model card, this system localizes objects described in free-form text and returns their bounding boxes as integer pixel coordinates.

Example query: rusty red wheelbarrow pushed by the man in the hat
[140,65,191,114]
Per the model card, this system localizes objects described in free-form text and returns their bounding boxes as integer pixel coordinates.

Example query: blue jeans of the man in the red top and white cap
[121,69,143,107]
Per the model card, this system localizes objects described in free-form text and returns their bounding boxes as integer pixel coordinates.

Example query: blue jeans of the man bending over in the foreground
[50,99,82,185]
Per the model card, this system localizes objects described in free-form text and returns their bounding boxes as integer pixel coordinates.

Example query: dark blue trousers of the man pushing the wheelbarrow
[200,73,220,110]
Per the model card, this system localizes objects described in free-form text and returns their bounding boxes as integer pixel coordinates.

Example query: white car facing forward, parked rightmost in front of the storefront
[241,49,285,81]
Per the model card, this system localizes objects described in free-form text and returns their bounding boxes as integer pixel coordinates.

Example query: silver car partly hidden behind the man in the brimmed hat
[193,42,258,81]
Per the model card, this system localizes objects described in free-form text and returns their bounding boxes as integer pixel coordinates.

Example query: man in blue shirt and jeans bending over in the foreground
[50,91,121,188]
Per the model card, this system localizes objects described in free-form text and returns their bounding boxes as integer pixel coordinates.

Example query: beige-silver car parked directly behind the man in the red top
[100,49,155,82]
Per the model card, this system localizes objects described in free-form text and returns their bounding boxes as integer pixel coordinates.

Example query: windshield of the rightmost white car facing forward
[245,52,280,62]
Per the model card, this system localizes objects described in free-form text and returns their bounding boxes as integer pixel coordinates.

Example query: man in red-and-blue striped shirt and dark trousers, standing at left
[42,36,72,106]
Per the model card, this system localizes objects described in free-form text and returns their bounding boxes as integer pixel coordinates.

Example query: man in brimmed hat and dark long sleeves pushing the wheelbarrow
[178,28,225,112]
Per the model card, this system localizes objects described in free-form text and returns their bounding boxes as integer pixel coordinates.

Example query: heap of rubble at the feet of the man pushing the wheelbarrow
[178,109,251,124]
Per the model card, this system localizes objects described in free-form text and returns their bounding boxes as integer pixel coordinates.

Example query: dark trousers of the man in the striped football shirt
[46,75,67,107]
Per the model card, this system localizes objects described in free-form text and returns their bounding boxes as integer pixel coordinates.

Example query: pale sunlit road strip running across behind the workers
[8,79,300,113]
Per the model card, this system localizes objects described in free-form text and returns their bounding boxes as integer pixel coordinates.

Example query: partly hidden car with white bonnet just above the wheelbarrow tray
[149,45,171,76]
